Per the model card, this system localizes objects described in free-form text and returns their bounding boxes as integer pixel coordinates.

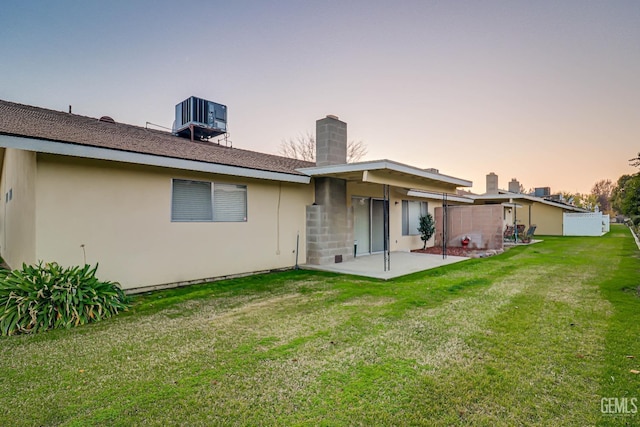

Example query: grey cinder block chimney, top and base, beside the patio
[306,116,354,265]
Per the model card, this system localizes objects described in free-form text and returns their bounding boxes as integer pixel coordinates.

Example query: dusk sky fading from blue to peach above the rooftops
[0,0,640,193]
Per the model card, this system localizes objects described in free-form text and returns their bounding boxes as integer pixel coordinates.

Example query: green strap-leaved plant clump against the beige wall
[0,262,129,335]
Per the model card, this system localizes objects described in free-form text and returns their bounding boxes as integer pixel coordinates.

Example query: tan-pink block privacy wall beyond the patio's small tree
[435,205,504,249]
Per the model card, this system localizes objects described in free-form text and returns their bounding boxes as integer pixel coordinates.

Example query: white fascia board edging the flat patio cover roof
[298,160,473,187]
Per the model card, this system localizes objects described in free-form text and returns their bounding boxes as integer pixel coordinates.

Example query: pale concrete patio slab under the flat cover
[300,252,469,280]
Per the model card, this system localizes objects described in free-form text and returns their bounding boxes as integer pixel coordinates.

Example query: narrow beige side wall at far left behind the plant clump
[0,148,36,268]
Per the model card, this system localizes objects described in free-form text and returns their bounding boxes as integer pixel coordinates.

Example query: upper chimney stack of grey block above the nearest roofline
[316,115,347,166]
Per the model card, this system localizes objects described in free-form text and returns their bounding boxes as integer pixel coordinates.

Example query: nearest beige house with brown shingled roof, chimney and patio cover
[0,101,471,291]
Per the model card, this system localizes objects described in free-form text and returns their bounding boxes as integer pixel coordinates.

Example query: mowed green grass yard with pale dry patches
[0,226,640,426]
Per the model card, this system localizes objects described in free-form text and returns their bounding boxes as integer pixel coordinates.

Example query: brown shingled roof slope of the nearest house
[0,100,315,175]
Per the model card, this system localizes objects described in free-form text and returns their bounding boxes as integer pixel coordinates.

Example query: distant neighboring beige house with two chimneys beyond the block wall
[468,173,589,236]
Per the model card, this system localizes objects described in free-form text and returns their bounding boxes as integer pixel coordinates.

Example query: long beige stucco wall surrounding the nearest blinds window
[36,155,313,289]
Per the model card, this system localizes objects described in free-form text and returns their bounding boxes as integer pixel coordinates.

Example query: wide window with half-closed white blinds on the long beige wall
[171,179,247,222]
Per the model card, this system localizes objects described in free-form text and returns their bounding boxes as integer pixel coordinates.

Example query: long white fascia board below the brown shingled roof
[0,135,311,184]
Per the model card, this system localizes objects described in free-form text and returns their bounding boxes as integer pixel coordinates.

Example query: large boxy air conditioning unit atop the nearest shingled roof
[173,96,227,139]
